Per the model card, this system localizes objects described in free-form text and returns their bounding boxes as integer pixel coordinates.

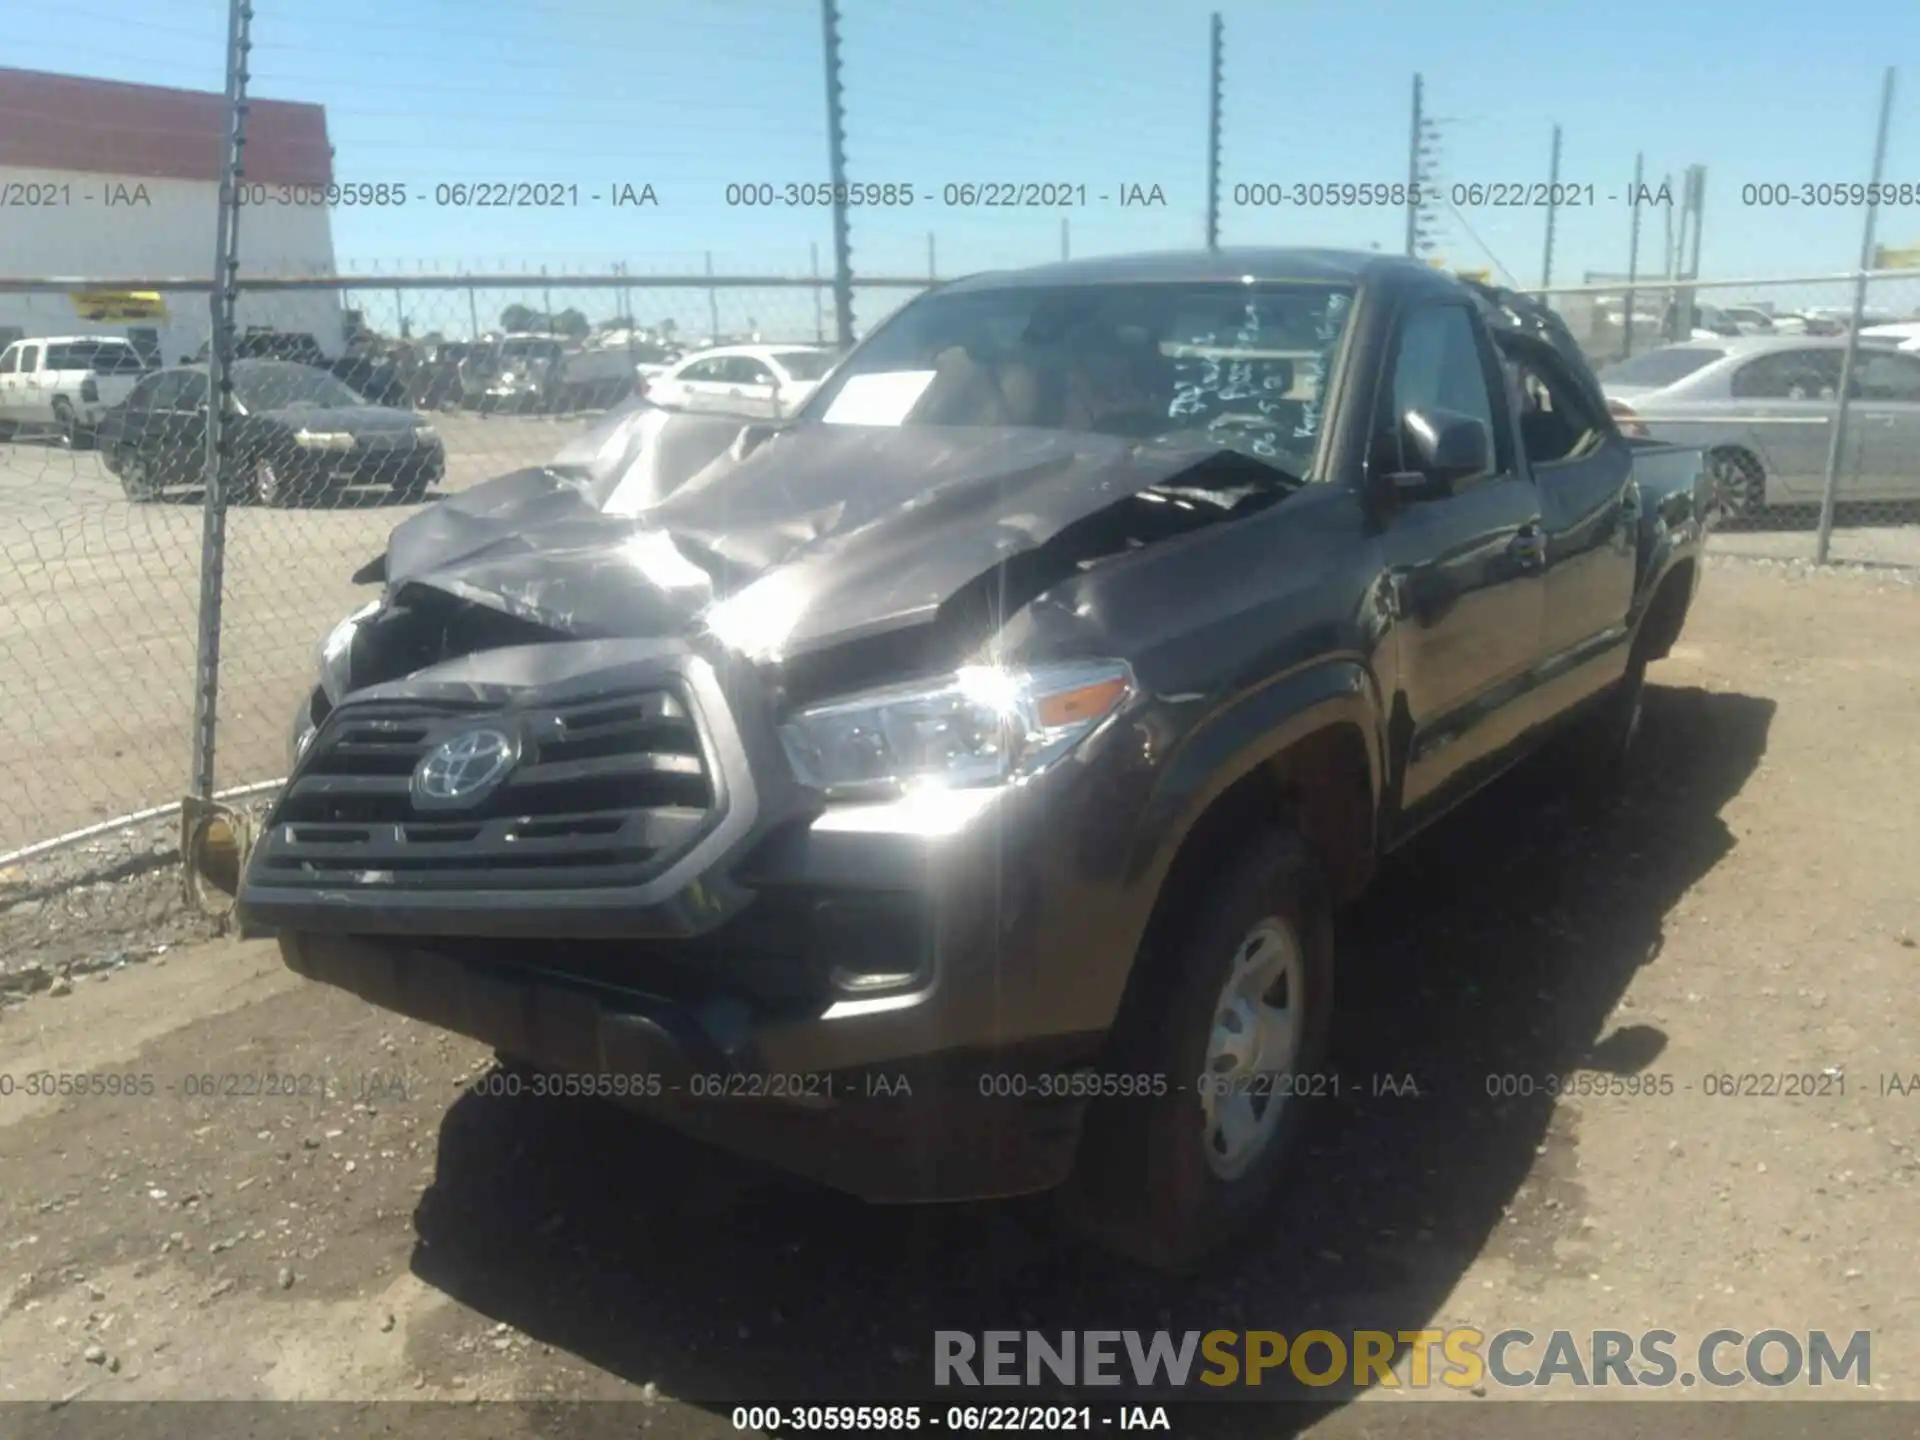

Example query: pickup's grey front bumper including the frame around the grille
[240,641,1135,1200]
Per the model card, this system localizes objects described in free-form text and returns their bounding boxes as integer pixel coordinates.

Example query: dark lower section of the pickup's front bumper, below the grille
[280,913,1085,1204]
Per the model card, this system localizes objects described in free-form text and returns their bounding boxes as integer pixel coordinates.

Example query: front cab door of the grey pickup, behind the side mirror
[1367,300,1548,833]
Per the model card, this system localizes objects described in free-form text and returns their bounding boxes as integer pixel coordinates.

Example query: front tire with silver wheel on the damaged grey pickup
[1060,831,1332,1271]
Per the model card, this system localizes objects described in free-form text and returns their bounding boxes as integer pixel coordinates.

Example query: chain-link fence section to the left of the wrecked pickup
[0,273,944,852]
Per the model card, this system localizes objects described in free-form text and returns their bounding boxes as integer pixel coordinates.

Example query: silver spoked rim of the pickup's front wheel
[1200,916,1306,1181]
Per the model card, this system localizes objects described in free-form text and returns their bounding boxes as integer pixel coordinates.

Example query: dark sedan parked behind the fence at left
[100,359,447,505]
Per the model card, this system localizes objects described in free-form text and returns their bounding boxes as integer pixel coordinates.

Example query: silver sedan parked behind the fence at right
[1599,332,1920,518]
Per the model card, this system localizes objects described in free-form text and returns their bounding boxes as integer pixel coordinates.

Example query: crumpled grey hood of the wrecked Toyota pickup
[374,403,1259,659]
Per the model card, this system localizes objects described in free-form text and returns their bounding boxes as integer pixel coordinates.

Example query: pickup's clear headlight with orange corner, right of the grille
[780,660,1135,799]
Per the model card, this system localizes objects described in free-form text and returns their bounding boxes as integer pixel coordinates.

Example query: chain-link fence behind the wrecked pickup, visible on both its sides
[0,263,1920,851]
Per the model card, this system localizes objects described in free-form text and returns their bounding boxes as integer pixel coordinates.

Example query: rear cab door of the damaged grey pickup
[1501,338,1640,683]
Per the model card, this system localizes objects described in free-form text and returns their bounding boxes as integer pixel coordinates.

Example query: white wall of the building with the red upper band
[0,167,346,365]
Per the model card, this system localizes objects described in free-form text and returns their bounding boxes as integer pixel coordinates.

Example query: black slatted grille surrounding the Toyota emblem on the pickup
[259,689,716,889]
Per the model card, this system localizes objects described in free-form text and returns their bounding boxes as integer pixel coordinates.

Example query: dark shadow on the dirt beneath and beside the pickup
[413,687,1774,1436]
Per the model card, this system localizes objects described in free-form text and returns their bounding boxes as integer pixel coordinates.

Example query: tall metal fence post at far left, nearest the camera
[188,0,253,801]
